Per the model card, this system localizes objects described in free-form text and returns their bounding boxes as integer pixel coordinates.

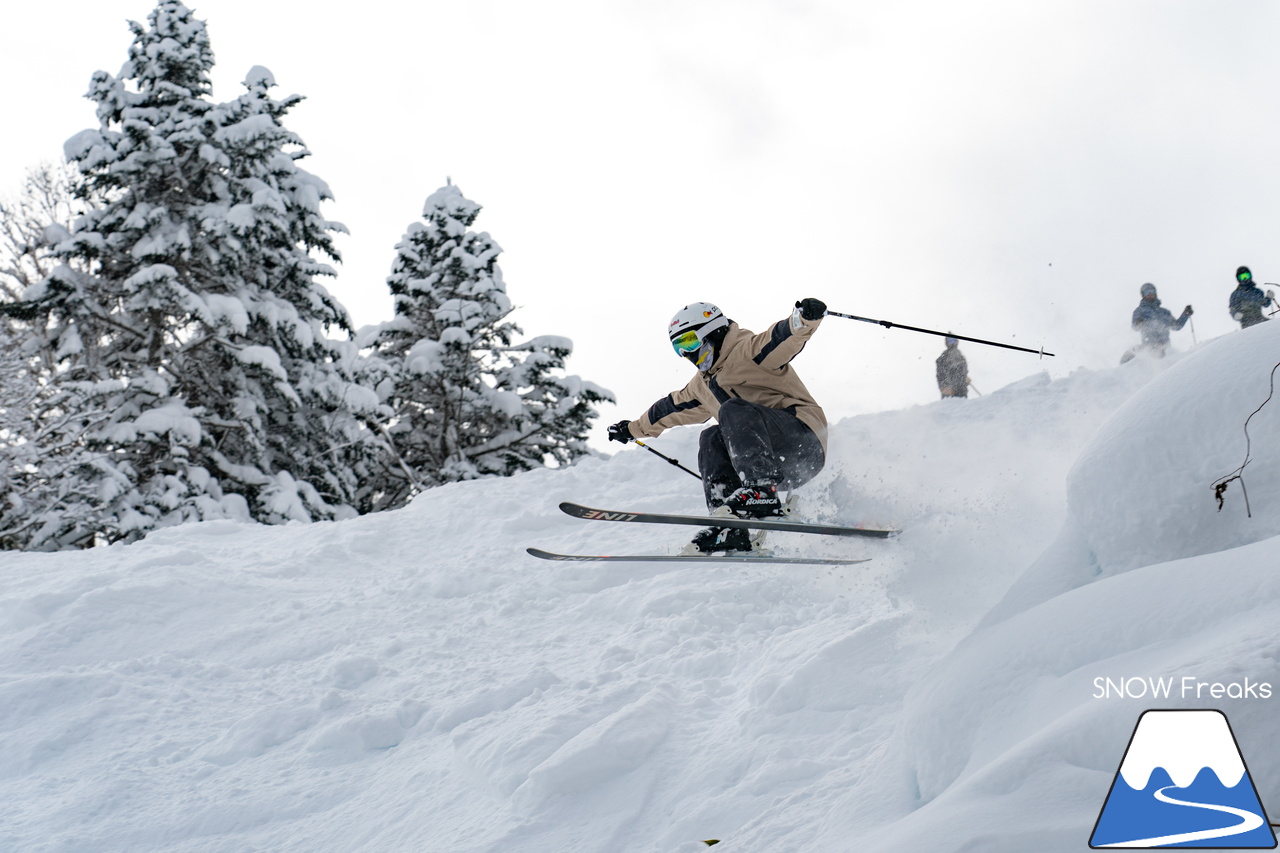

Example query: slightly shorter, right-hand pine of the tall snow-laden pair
[201,67,387,521]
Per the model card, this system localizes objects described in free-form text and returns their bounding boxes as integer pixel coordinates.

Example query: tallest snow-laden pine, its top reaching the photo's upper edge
[11,0,247,547]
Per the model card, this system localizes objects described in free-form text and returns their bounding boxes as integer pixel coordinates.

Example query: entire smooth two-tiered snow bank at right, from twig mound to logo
[844,324,1280,853]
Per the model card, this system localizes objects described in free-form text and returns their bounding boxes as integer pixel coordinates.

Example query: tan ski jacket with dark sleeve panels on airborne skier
[628,313,827,451]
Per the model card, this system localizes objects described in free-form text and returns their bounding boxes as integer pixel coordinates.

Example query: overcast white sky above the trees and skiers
[0,0,1280,448]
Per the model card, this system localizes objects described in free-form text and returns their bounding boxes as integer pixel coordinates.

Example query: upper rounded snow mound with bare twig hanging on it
[1068,317,1280,574]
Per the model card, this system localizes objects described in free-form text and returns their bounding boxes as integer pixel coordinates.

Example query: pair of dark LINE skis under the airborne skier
[526,501,901,566]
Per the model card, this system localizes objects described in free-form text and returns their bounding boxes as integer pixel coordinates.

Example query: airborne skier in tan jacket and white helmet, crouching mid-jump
[609,298,827,553]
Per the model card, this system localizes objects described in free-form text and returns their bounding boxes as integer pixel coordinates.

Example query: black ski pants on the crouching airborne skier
[698,397,827,510]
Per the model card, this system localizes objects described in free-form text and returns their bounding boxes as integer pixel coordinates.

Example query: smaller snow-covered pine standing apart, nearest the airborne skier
[376,182,612,507]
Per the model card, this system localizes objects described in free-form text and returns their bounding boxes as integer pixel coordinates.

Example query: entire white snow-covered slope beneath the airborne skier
[0,323,1280,853]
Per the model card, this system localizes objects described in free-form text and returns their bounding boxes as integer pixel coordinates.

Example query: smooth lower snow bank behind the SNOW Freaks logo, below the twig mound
[859,527,1280,853]
